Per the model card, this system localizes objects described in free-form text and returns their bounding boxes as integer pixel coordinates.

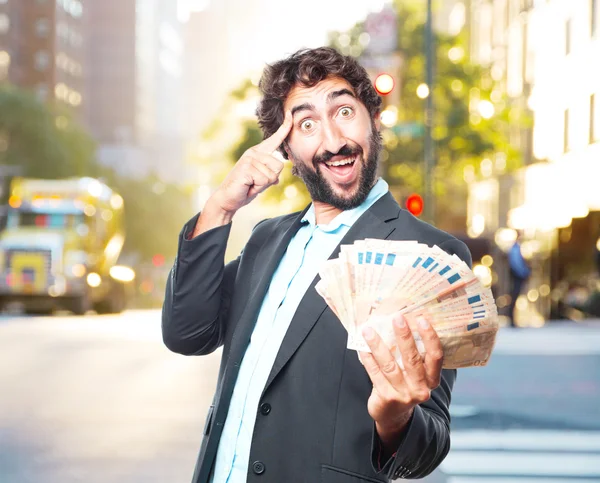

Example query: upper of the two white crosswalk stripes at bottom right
[451,430,600,459]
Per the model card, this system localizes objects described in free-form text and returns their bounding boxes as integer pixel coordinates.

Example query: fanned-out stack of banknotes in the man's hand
[316,239,498,369]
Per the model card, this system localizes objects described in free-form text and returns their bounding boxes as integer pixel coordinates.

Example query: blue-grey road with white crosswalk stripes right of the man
[426,320,600,483]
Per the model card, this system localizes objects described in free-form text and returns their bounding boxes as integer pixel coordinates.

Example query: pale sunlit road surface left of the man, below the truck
[0,311,219,483]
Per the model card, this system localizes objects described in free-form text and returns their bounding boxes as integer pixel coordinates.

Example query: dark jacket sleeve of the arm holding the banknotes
[371,238,472,480]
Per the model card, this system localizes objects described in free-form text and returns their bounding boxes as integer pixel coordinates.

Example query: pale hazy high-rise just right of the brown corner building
[85,0,186,182]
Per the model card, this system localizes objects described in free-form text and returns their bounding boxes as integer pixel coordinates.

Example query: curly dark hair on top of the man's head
[256,47,382,159]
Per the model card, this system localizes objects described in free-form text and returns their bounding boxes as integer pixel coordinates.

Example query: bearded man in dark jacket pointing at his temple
[163,48,471,483]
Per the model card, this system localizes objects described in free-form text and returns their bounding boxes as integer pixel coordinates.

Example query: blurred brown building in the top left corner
[0,0,86,114]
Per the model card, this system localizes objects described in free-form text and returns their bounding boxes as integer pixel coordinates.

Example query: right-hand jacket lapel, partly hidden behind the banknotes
[264,192,400,391]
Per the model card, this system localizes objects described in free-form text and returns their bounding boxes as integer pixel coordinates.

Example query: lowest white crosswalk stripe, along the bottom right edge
[440,451,600,483]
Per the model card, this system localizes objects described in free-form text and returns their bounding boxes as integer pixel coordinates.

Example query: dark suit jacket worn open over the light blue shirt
[162,193,471,483]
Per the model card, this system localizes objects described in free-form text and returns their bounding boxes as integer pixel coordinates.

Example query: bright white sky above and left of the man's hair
[178,0,394,138]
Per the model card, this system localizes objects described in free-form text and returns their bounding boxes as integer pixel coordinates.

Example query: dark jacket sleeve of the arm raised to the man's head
[162,215,240,355]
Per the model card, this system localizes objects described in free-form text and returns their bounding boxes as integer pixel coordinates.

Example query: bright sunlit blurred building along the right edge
[468,0,600,321]
